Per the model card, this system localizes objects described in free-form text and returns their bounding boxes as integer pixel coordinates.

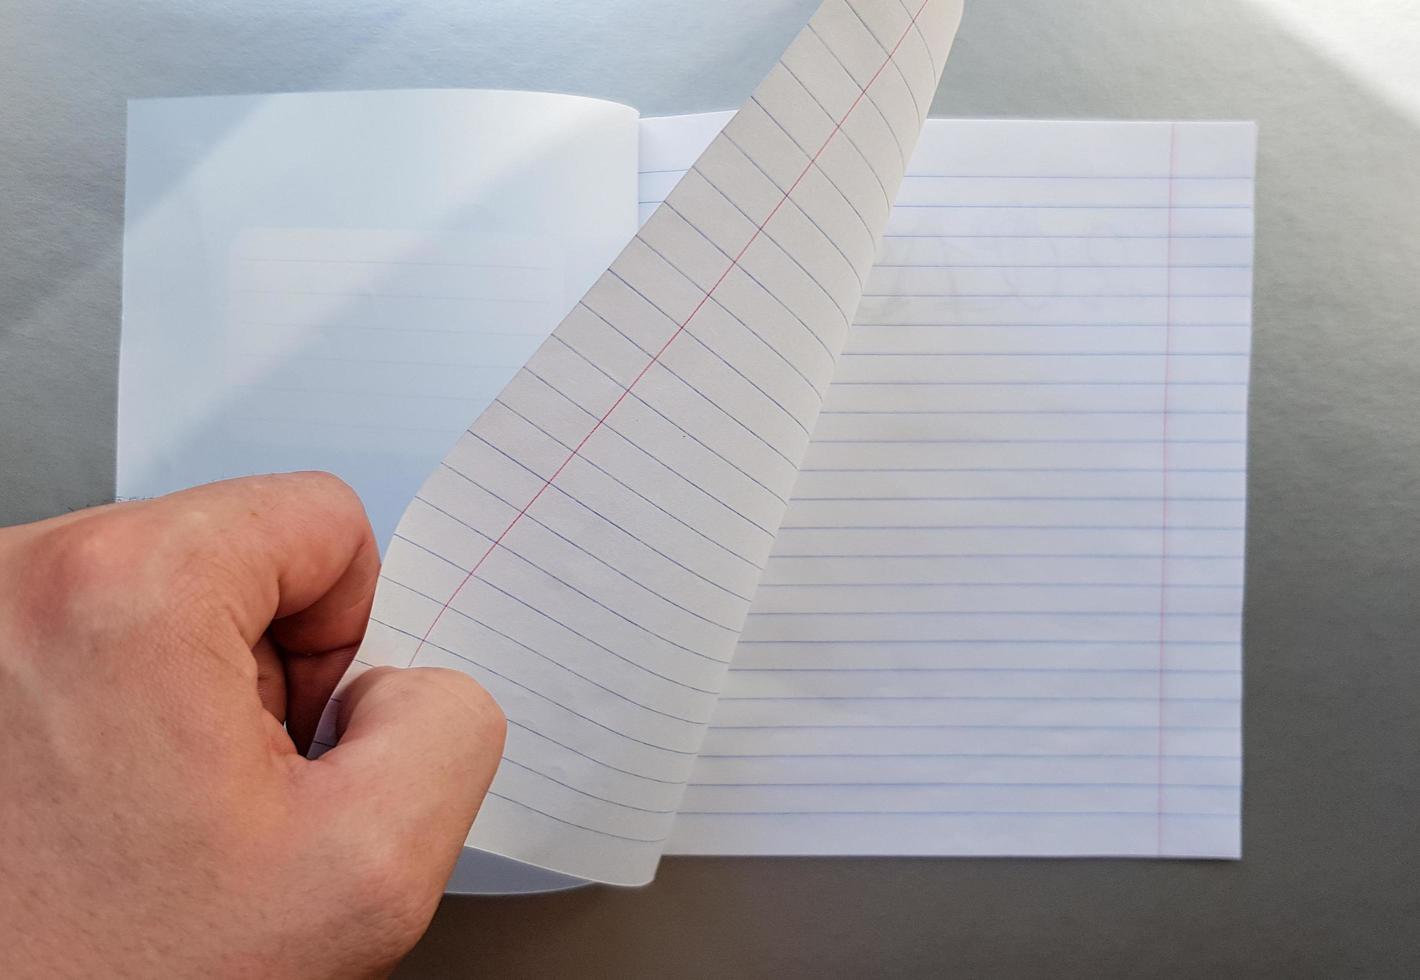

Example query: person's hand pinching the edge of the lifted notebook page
[0,473,504,977]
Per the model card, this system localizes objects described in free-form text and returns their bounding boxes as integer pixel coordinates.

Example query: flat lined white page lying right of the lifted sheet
[653,119,1255,858]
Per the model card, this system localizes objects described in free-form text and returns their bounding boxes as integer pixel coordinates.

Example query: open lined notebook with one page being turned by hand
[118,0,1255,883]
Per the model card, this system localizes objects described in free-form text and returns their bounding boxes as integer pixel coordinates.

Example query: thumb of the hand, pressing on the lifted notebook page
[311,668,506,902]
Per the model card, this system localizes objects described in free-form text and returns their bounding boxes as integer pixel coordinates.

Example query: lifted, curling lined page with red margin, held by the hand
[353,0,960,883]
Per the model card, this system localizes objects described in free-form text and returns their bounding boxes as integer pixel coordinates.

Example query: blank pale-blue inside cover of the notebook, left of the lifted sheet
[118,91,636,543]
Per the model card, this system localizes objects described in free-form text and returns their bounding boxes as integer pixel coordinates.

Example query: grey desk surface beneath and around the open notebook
[0,0,1420,977]
